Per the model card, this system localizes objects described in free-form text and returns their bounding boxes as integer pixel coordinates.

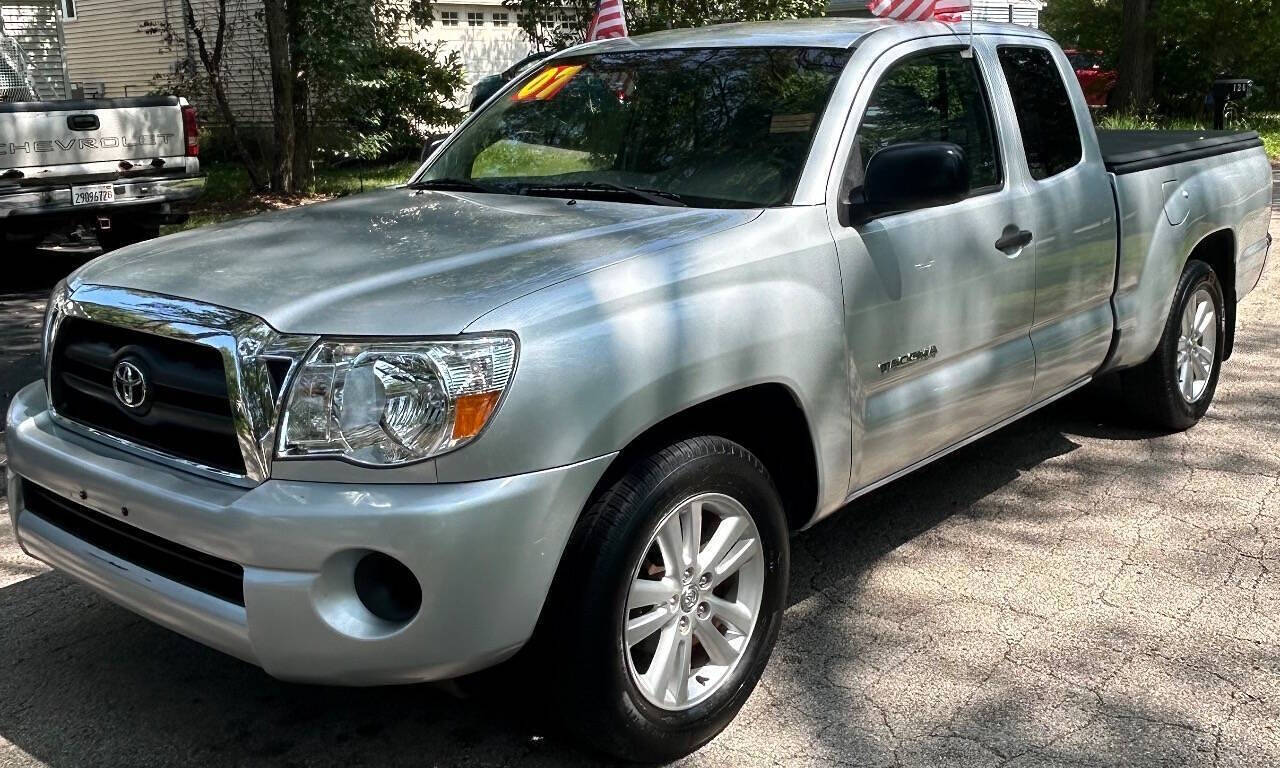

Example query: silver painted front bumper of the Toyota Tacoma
[6,383,612,685]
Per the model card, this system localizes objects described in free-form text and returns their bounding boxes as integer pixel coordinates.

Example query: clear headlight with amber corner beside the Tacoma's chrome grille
[279,335,516,466]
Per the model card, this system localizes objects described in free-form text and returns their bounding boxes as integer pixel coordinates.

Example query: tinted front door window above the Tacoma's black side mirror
[858,50,1001,193]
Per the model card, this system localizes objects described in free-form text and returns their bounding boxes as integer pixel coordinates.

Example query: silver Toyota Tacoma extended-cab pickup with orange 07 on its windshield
[6,19,1271,760]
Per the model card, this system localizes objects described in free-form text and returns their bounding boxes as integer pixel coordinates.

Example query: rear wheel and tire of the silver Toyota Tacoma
[1121,260,1226,430]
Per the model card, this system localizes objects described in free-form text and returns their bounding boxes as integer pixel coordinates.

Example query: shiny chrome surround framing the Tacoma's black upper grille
[45,285,319,485]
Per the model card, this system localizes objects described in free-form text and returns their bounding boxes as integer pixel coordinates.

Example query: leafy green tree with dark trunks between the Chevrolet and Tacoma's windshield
[142,0,463,195]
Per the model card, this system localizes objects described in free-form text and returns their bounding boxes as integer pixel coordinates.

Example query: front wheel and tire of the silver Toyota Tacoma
[534,436,790,762]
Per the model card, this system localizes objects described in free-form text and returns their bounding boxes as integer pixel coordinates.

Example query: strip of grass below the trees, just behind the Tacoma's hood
[166,160,419,232]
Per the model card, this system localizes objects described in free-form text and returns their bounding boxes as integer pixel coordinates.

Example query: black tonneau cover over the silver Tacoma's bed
[1098,129,1262,174]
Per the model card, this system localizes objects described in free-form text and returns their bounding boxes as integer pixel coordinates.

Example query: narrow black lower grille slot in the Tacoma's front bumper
[22,480,244,605]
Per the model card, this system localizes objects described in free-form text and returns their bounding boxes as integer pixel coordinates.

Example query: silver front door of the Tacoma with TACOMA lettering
[828,38,1036,490]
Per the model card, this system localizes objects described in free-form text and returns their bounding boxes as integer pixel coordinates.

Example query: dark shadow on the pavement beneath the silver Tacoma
[0,398,1162,768]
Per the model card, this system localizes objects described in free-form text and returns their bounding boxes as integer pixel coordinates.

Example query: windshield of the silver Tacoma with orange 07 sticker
[415,47,850,207]
